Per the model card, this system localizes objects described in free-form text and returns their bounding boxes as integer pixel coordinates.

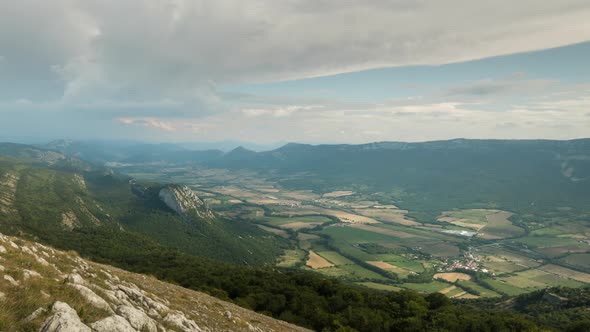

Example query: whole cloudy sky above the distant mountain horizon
[0,0,590,144]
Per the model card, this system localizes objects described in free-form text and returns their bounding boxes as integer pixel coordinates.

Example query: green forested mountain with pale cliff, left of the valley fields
[0,144,285,264]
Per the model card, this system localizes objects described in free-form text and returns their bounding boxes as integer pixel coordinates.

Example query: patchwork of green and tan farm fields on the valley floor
[130,170,590,299]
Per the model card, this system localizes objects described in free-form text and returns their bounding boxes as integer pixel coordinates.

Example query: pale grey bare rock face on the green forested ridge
[158,185,215,219]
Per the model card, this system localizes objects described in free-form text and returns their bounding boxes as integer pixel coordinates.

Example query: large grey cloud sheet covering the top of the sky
[0,0,590,102]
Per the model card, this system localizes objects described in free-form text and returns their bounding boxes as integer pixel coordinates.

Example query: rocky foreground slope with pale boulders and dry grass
[0,234,305,332]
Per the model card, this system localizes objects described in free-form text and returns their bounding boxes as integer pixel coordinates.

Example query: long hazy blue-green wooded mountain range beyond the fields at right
[205,139,590,221]
